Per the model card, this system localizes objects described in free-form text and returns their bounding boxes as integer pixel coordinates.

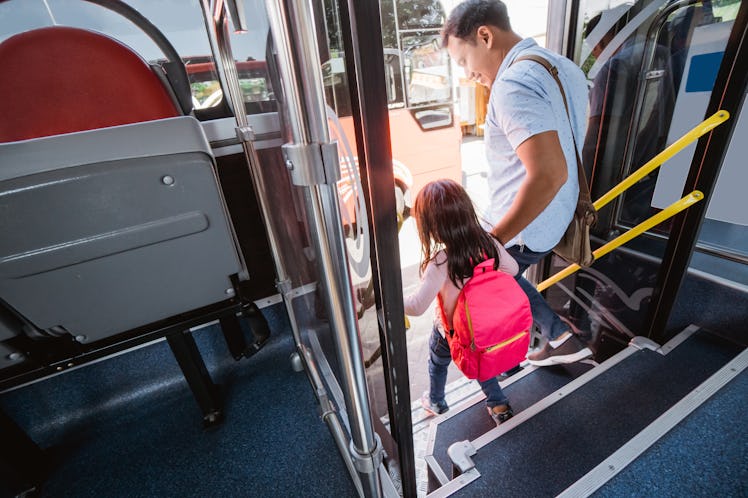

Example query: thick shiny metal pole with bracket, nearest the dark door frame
[266,0,382,496]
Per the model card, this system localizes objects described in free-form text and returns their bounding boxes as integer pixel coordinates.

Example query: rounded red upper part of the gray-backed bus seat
[0,26,181,142]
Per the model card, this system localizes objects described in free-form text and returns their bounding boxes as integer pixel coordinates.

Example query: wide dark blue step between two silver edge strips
[430,327,743,496]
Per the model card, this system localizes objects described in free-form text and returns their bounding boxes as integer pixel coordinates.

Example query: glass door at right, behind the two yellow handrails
[549,1,748,359]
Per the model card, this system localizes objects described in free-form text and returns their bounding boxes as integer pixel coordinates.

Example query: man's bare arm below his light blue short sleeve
[491,131,568,243]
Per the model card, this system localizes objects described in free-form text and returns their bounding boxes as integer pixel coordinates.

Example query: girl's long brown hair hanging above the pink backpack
[413,179,499,287]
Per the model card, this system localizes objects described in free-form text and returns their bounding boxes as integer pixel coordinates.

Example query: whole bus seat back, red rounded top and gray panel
[0,27,243,343]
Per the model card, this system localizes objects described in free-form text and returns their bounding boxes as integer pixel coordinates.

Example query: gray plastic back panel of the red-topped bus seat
[0,116,242,343]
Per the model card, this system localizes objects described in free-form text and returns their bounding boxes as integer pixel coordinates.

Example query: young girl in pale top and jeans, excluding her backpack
[405,180,518,424]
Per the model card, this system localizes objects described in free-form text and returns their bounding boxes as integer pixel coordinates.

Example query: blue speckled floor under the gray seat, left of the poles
[0,310,355,497]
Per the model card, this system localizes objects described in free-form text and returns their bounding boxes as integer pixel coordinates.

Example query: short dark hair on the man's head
[442,0,512,47]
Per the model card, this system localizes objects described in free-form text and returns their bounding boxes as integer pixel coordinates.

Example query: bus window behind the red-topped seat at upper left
[0,0,277,119]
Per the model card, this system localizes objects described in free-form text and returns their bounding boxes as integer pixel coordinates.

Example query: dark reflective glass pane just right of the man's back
[582,2,676,231]
